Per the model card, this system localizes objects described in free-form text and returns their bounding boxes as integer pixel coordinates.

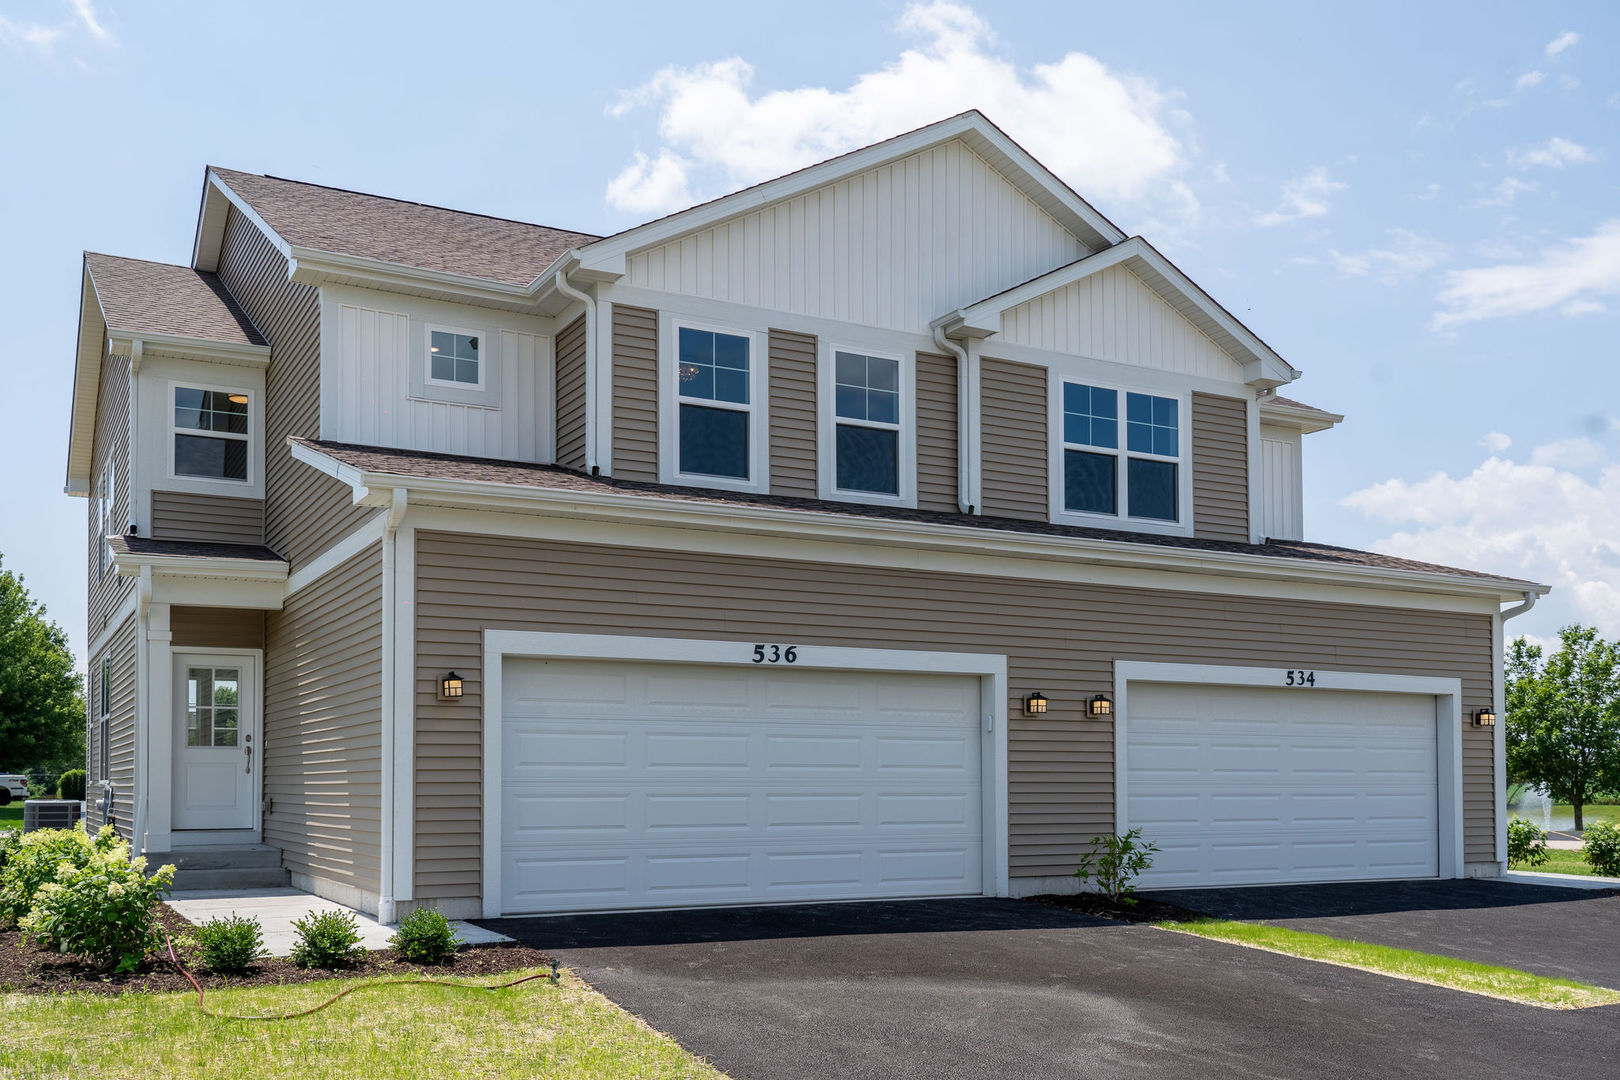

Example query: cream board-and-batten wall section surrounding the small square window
[321,285,556,461]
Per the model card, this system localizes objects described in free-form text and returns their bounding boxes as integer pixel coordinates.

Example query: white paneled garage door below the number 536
[501,659,983,913]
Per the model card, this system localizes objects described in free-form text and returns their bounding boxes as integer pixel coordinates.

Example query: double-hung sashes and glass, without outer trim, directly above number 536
[674,325,758,481]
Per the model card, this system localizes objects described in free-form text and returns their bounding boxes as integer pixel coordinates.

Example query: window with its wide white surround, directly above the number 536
[659,319,770,491]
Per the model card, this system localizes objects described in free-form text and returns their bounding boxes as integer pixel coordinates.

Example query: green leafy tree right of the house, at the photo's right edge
[1503,625,1620,829]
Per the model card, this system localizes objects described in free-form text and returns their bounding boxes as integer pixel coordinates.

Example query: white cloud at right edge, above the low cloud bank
[1430,219,1620,329]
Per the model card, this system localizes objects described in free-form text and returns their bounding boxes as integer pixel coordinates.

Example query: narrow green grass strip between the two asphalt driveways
[1157,918,1620,1009]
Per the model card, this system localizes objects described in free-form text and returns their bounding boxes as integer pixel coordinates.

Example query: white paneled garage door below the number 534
[1126,683,1440,889]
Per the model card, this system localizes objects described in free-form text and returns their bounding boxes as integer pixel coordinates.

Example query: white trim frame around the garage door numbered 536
[481,630,1011,918]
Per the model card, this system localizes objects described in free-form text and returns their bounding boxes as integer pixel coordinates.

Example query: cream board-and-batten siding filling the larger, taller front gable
[625,141,1087,332]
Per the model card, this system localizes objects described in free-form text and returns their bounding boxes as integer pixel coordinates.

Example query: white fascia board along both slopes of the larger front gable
[580,110,1124,274]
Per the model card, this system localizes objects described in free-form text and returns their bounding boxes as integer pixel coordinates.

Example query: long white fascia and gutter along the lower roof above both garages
[295,444,1549,601]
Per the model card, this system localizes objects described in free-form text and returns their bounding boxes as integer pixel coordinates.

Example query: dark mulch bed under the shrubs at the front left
[0,905,551,994]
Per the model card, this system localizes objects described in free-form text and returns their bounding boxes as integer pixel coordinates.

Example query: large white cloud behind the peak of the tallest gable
[608,0,1196,221]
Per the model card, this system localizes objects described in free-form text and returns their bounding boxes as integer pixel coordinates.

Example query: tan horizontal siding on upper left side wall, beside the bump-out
[219,209,373,570]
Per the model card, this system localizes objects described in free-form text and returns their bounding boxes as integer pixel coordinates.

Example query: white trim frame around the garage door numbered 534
[1113,661,1466,878]
